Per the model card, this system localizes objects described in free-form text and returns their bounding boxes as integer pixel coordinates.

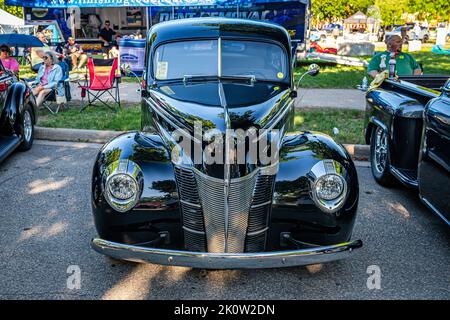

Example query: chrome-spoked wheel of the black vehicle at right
[370,127,395,187]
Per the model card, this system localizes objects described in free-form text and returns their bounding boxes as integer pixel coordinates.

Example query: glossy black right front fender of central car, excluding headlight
[270,132,359,245]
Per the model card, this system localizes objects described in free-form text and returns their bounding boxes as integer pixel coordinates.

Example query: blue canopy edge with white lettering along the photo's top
[5,0,308,8]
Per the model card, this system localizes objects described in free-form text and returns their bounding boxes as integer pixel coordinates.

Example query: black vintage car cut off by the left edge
[0,62,37,162]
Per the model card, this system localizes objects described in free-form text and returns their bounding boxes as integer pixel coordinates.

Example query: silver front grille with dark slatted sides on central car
[175,167,275,253]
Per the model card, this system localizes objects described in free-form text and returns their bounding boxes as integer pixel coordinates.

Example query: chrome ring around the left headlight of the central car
[103,160,143,213]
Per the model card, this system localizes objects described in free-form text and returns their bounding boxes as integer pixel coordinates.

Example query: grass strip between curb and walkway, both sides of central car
[38,105,364,143]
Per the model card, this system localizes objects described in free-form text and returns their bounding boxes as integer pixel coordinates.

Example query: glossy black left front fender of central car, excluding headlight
[91,132,180,244]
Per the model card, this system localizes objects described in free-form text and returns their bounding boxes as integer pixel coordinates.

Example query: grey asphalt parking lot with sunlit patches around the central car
[0,141,450,299]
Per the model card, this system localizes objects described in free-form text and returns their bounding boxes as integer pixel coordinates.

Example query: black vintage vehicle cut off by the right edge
[365,75,450,226]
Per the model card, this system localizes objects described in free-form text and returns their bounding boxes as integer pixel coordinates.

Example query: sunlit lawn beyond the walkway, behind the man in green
[294,48,450,89]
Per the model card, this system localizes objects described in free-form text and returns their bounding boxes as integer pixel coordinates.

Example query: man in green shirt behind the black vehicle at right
[367,35,422,78]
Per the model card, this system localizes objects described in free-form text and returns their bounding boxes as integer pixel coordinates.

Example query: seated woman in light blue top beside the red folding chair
[32,51,63,108]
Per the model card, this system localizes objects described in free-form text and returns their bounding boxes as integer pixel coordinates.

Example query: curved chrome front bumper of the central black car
[91,238,362,269]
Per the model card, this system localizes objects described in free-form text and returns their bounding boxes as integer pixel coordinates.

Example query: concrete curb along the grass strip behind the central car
[34,126,370,160]
